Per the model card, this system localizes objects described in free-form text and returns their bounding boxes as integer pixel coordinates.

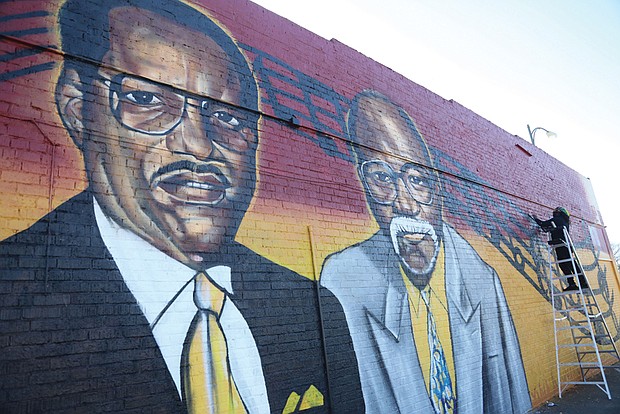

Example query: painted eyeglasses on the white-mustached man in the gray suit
[359,160,437,205]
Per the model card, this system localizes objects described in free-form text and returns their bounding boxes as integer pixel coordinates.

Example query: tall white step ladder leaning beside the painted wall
[548,228,620,399]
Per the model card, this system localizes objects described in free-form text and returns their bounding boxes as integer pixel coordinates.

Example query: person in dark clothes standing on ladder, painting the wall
[531,207,588,292]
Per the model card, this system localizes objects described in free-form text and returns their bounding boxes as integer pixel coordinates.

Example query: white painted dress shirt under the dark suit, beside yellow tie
[94,200,270,414]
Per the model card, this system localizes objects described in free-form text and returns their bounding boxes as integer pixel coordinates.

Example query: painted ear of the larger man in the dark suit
[56,69,84,149]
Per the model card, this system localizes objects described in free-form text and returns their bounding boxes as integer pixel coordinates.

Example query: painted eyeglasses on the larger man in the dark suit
[98,73,253,152]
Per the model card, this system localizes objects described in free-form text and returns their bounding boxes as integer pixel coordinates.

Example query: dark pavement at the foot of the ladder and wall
[529,363,620,414]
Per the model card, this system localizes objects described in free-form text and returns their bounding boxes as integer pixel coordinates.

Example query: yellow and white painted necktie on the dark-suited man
[181,272,247,414]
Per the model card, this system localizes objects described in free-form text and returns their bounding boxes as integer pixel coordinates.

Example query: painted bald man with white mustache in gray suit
[321,91,531,414]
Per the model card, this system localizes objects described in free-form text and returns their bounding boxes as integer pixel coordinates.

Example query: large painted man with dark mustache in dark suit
[0,0,363,413]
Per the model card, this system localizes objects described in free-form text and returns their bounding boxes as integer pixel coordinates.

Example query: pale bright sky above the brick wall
[252,0,620,243]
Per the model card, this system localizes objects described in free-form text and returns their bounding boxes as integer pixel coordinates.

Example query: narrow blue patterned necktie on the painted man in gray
[420,291,454,414]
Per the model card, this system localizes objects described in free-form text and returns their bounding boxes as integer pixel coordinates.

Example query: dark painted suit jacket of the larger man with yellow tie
[0,192,364,413]
